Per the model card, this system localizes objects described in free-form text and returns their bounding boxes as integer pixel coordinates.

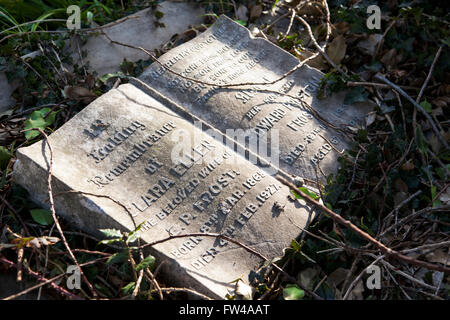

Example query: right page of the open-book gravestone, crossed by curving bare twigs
[134,16,369,181]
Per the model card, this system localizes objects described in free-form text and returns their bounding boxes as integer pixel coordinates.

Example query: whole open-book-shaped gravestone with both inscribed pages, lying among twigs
[13,17,372,298]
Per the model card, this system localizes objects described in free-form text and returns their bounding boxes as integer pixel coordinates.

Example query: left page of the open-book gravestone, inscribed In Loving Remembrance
[13,84,314,298]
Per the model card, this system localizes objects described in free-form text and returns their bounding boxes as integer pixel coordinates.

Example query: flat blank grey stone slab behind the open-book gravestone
[71,1,204,76]
